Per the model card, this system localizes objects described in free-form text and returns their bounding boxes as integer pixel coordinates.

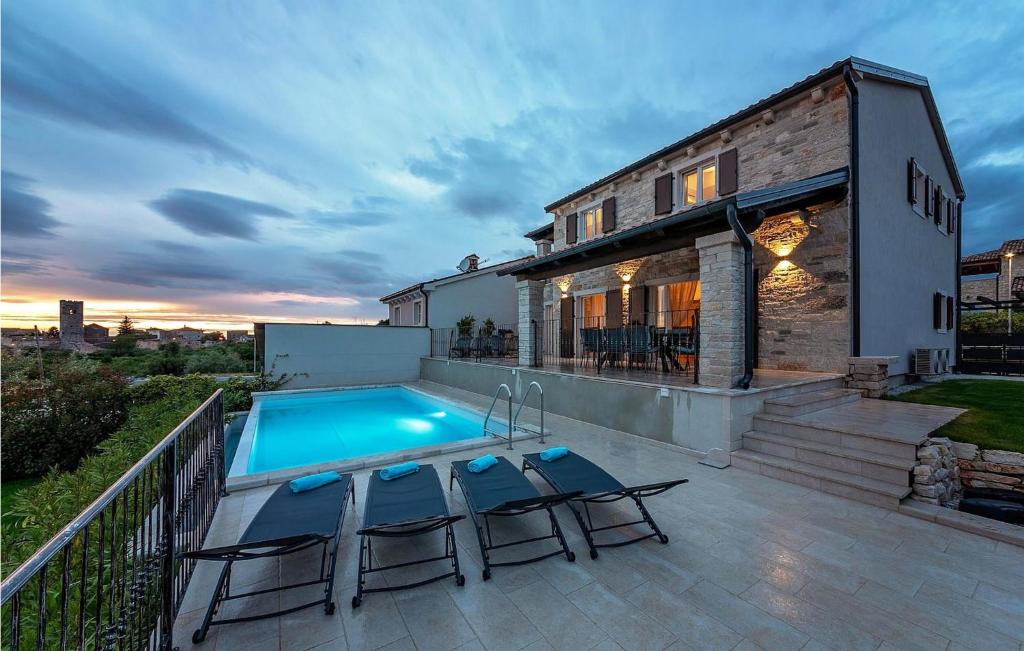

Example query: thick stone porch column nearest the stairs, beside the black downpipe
[696,230,743,389]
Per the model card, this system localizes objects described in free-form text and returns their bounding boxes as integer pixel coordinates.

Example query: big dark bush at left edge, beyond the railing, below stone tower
[0,357,128,478]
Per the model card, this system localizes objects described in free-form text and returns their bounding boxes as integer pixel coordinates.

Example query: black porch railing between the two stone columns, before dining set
[535,309,700,382]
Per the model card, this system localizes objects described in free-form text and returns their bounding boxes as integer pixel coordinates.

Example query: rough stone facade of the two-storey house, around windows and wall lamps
[546,79,850,373]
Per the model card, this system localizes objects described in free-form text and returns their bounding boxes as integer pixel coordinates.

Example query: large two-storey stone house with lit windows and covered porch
[499,57,962,388]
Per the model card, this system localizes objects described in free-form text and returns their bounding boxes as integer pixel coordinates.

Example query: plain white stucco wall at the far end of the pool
[264,323,430,389]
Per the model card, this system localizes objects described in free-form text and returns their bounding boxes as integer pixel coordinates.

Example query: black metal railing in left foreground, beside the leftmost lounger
[0,389,225,650]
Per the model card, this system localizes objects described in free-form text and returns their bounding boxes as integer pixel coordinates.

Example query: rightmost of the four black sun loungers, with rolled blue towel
[522,451,689,558]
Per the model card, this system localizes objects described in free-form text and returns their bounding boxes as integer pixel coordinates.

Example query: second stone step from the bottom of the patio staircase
[743,431,915,485]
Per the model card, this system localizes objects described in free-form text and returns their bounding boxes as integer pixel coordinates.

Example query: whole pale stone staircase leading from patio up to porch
[732,388,927,509]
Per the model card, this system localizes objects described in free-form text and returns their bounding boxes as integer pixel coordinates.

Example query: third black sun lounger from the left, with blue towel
[449,457,580,580]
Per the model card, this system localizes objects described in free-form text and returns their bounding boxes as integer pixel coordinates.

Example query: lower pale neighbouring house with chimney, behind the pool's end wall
[381,254,534,328]
